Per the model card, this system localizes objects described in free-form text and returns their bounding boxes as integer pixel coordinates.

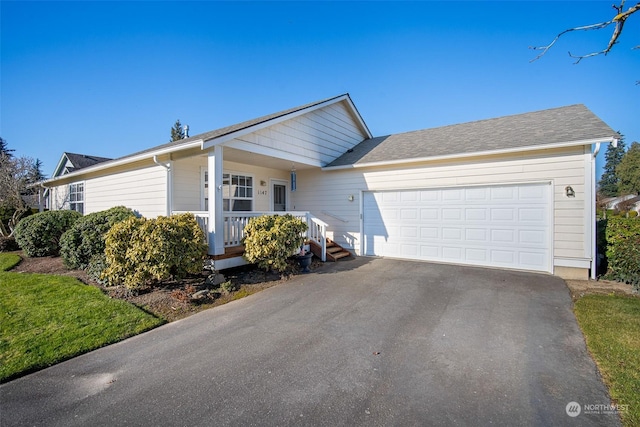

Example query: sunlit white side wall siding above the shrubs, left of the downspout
[85,166,167,218]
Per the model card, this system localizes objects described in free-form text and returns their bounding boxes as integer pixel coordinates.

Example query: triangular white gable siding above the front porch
[226,103,365,166]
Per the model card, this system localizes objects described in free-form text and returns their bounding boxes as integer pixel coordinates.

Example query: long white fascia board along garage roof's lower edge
[322,137,615,170]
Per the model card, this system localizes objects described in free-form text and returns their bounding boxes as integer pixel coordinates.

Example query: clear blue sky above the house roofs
[0,1,640,175]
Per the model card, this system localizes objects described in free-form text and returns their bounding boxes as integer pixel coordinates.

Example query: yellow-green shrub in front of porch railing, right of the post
[243,214,307,272]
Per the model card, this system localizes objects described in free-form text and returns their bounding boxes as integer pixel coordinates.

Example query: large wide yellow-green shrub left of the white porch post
[102,214,207,289]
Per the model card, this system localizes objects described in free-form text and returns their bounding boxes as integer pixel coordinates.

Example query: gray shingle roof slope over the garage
[327,104,619,167]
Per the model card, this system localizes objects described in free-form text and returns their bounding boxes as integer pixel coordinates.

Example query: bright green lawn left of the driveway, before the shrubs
[0,253,164,382]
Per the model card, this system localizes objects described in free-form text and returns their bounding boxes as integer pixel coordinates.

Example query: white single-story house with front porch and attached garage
[44,94,619,278]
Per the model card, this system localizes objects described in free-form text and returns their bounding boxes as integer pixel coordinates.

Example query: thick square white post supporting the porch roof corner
[207,145,224,255]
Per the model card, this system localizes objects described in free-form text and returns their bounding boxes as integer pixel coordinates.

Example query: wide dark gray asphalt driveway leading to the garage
[0,258,619,426]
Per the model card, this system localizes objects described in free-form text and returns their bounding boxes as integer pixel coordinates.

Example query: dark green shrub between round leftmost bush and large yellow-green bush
[60,206,135,270]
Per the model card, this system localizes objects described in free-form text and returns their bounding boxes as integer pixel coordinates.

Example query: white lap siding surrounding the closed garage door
[293,147,589,268]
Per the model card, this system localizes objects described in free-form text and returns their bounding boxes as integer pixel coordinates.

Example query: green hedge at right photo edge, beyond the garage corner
[606,217,640,290]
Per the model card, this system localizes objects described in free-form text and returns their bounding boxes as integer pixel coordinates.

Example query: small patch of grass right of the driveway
[574,295,640,426]
